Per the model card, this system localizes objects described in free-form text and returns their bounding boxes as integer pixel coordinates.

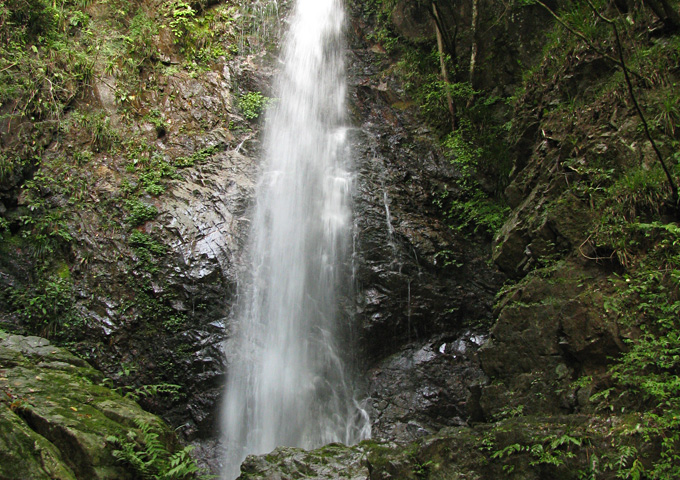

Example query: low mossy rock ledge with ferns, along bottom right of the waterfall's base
[239,415,639,480]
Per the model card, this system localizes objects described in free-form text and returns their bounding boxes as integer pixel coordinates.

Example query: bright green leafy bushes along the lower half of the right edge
[593,222,680,480]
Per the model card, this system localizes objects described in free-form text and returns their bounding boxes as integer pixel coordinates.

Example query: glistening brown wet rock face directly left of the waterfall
[21,49,269,437]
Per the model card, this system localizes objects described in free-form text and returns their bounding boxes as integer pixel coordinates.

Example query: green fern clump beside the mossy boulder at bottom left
[106,420,207,480]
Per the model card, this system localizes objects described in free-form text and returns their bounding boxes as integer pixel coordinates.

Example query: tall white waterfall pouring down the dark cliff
[223,0,370,479]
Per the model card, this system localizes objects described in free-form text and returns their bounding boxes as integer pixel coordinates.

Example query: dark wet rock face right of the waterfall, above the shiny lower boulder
[350,45,499,358]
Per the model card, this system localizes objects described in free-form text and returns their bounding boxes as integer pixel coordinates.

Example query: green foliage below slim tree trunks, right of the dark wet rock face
[388,37,512,236]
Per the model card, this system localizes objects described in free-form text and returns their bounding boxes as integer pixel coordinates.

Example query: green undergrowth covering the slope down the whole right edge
[510,0,680,480]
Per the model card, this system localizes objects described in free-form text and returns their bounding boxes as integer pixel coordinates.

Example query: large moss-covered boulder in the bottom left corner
[0,335,176,480]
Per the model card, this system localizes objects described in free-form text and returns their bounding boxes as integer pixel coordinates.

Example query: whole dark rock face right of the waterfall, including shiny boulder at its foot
[349,3,501,442]
